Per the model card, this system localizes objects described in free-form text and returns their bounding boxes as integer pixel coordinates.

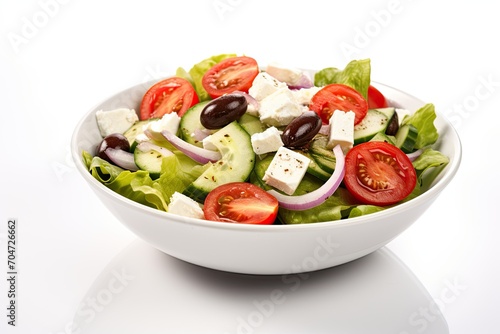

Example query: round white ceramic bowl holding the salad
[71,79,461,274]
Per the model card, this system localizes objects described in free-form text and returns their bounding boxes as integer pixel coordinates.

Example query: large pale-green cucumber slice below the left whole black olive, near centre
[183,121,255,203]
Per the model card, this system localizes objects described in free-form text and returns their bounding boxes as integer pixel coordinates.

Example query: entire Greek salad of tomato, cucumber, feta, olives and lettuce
[82,54,448,224]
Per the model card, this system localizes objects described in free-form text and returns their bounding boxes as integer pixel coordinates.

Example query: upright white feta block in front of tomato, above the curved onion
[327,110,355,153]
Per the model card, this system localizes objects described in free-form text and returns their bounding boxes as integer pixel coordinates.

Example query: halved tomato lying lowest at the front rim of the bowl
[203,182,278,225]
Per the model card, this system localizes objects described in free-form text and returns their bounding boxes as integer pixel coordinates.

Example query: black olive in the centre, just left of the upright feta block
[281,111,322,148]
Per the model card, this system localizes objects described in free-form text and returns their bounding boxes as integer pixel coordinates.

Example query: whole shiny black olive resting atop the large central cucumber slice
[200,94,248,130]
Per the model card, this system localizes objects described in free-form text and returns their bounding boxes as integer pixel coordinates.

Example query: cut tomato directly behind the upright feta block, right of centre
[309,84,368,125]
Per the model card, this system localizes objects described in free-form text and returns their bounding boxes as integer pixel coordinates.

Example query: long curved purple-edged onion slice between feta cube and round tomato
[268,145,345,211]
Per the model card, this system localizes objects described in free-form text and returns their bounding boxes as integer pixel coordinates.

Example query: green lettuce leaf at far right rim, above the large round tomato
[402,103,439,149]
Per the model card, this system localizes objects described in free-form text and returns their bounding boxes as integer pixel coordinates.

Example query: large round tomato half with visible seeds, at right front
[344,142,417,206]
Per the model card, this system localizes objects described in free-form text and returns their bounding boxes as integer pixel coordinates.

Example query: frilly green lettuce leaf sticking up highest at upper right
[314,59,371,99]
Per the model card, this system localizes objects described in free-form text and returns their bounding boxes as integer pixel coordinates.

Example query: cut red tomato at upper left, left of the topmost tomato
[140,77,199,120]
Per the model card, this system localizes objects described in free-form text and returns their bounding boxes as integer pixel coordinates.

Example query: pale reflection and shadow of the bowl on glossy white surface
[73,240,449,334]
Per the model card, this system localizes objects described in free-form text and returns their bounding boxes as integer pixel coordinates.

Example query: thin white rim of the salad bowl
[71,79,462,232]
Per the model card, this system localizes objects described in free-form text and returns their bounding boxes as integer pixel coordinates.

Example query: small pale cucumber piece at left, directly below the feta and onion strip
[134,142,174,179]
